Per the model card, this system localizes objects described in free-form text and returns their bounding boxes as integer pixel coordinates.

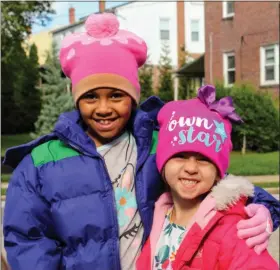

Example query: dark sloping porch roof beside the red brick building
[176,54,204,78]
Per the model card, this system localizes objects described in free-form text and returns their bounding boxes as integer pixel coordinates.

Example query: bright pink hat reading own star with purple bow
[156,85,242,177]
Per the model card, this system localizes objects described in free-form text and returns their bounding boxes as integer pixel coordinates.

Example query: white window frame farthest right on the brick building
[260,44,279,86]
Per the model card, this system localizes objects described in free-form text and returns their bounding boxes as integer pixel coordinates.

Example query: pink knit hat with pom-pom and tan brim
[60,13,147,103]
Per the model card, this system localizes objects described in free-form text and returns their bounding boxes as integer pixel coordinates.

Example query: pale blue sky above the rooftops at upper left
[32,1,125,34]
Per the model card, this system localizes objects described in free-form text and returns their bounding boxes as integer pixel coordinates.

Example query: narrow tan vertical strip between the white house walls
[177,1,185,67]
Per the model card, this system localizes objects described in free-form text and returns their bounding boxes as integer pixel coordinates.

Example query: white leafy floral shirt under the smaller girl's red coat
[153,207,187,270]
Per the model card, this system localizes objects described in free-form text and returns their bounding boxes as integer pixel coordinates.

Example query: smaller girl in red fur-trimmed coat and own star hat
[137,86,279,270]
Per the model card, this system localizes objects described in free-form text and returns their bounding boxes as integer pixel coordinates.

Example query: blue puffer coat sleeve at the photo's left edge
[3,155,62,270]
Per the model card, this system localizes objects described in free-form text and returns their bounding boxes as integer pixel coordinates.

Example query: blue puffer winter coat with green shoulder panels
[4,97,279,270]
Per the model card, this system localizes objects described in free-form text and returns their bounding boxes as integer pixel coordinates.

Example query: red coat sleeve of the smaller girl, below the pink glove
[218,218,279,270]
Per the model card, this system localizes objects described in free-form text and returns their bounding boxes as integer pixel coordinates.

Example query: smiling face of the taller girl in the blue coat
[78,88,134,147]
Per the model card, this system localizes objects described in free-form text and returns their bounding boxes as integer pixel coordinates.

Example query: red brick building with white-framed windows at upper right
[205,1,280,93]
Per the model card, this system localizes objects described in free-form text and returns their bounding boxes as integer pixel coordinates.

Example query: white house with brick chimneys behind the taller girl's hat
[52,1,205,93]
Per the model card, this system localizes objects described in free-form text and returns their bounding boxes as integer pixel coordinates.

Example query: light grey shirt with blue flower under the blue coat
[97,132,144,270]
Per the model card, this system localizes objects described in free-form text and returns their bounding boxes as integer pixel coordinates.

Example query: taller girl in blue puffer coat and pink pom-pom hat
[4,14,278,270]
